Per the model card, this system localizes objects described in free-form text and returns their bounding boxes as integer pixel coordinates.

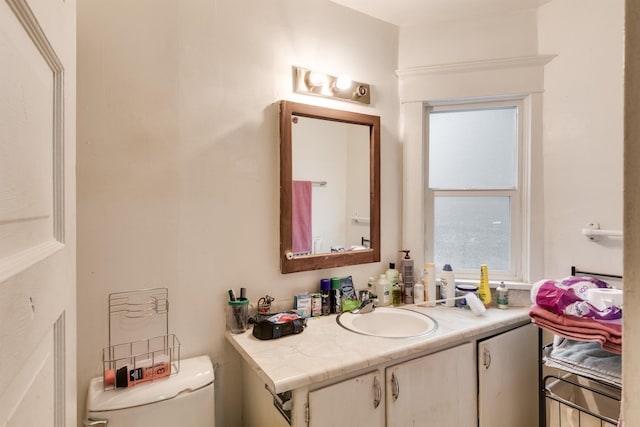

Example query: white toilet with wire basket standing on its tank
[84,356,215,427]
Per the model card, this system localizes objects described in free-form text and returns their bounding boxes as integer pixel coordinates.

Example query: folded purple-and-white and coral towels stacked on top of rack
[529,277,622,354]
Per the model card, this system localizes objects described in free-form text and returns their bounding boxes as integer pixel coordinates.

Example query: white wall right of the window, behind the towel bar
[538,0,624,277]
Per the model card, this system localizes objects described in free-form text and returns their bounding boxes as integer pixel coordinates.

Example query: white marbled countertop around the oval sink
[226,306,530,393]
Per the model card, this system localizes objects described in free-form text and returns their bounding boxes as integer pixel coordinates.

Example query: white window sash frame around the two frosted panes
[423,96,531,282]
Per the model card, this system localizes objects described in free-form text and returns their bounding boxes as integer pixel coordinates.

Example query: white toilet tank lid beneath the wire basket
[87,356,214,412]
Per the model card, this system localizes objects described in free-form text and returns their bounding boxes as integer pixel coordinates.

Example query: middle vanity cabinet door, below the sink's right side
[386,343,476,427]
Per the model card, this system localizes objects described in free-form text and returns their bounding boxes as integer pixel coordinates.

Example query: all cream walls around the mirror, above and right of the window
[77,0,637,427]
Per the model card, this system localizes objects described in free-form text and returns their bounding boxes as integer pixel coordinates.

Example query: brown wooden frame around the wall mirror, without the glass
[280,101,380,274]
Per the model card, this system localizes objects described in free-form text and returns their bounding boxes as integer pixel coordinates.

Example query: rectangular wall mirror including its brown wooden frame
[280,101,380,273]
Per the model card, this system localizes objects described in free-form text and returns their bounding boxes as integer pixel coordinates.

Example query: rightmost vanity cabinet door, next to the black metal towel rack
[478,324,538,427]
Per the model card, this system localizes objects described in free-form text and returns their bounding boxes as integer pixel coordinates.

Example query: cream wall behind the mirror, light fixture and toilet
[77,0,401,427]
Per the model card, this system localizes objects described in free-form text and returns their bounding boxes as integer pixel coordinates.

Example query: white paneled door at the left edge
[0,0,76,427]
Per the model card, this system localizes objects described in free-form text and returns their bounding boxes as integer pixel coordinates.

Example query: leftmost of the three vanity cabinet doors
[309,371,384,427]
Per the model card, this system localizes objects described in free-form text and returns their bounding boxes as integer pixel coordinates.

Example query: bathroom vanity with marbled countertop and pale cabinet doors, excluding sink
[227,307,538,427]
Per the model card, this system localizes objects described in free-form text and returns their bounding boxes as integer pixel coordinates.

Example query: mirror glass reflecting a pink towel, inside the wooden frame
[291,117,370,256]
